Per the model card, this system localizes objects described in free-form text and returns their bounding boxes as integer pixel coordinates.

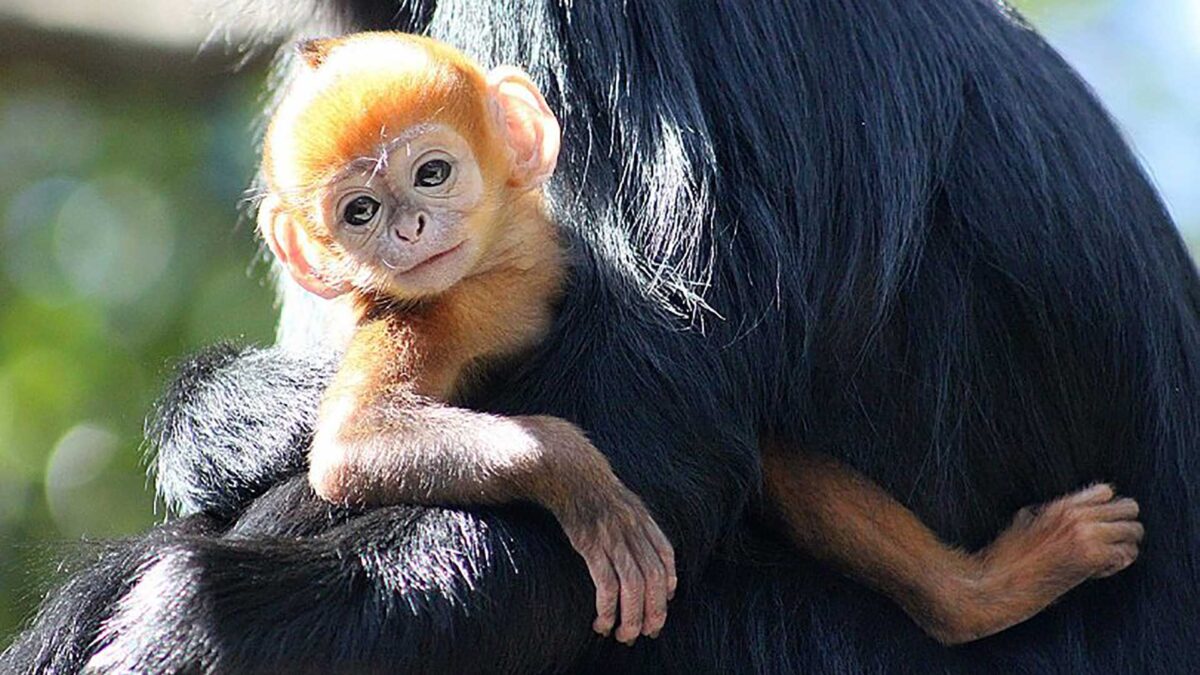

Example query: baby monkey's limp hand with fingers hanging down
[559,488,677,645]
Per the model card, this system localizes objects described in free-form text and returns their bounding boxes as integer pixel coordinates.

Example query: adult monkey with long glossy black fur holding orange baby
[4,0,1200,673]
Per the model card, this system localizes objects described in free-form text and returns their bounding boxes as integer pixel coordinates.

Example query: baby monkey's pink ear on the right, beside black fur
[487,66,560,190]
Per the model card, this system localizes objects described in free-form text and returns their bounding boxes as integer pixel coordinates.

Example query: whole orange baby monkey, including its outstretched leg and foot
[258,34,1141,644]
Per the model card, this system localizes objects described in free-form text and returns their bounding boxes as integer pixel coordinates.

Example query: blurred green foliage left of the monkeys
[0,34,275,647]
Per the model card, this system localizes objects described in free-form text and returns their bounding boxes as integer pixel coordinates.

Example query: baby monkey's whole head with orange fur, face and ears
[258,32,559,299]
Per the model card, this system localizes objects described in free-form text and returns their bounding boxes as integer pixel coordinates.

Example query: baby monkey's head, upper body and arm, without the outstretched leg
[259,34,676,643]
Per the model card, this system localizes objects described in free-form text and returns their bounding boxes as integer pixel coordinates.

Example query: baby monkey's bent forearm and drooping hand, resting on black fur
[310,404,676,643]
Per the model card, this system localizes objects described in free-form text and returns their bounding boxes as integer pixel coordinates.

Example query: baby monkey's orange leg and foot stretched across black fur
[763,448,1142,645]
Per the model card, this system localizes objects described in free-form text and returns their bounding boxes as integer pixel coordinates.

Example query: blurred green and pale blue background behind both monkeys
[0,0,1200,649]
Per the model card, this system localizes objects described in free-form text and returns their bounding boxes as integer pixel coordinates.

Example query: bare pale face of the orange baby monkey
[316,124,490,297]
